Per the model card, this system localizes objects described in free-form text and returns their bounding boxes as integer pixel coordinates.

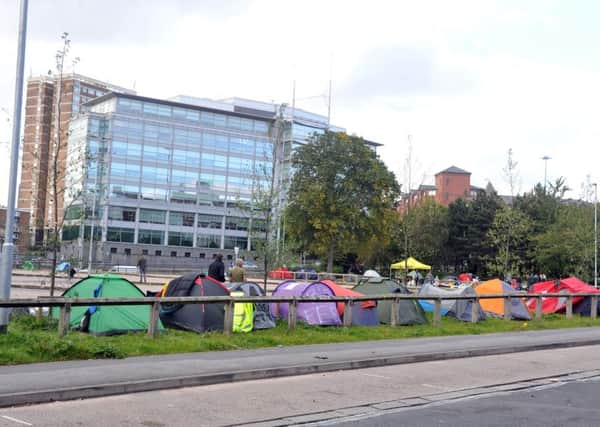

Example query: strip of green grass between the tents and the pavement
[0,315,600,365]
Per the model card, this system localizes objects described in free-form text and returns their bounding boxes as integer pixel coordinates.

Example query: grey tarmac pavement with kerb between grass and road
[0,327,600,407]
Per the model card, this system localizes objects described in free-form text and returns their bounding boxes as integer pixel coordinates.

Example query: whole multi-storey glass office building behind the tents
[63,93,380,266]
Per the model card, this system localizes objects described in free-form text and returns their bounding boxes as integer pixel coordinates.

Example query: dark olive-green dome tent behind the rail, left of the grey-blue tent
[353,277,427,325]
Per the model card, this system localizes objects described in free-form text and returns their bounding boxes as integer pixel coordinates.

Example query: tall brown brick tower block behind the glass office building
[17,74,134,246]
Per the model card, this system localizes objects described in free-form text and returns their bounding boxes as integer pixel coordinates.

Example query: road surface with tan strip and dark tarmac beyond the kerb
[0,346,600,427]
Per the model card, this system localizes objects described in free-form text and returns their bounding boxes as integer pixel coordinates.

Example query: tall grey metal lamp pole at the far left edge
[0,0,28,334]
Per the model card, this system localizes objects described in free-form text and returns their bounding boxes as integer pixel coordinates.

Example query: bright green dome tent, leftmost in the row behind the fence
[52,274,163,335]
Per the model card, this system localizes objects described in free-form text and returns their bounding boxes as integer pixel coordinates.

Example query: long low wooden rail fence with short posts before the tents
[0,292,600,337]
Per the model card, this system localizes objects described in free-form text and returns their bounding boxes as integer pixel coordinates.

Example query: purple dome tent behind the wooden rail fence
[271,280,342,325]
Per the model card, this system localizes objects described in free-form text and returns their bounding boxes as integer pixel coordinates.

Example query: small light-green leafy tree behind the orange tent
[484,207,531,277]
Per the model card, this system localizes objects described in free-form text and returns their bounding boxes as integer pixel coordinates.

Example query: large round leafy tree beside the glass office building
[286,131,399,272]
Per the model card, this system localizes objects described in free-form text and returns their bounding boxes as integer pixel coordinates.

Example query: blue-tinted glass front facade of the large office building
[66,94,273,254]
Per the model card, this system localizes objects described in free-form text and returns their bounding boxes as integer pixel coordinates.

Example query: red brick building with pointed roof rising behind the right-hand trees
[397,166,485,213]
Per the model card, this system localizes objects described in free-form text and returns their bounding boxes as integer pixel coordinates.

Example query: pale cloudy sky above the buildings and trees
[0,0,600,203]
